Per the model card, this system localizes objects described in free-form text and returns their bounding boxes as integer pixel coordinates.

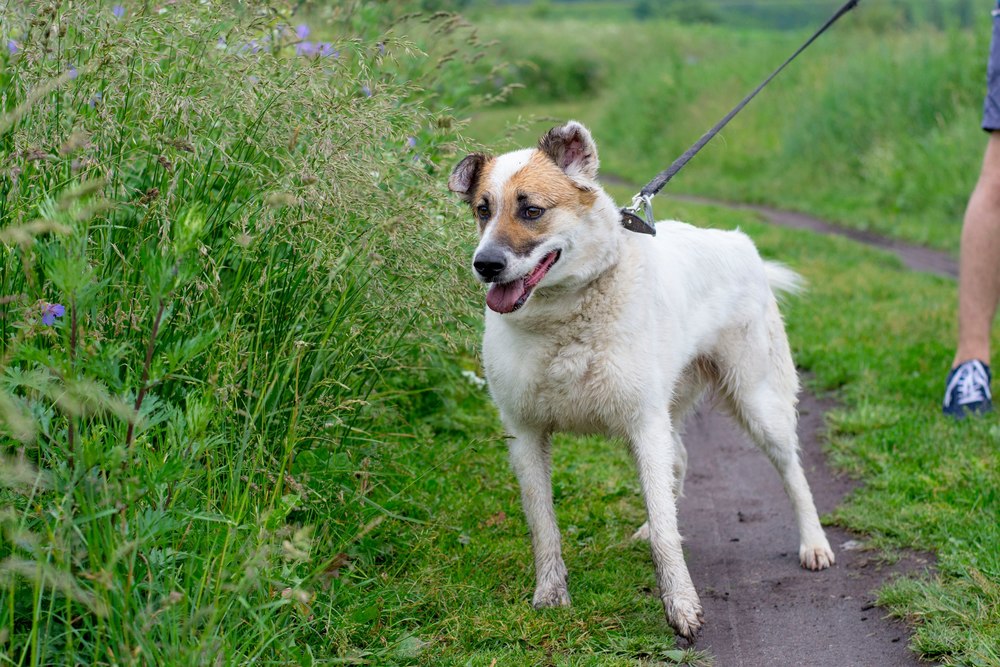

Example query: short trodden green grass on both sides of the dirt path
[316,188,1000,665]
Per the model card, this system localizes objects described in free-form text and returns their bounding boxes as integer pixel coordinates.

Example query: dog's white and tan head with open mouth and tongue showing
[448,121,615,313]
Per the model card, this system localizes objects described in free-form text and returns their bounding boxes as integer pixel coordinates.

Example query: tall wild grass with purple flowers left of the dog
[0,1,478,665]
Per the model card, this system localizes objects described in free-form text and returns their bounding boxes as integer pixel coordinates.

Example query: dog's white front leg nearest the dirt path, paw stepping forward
[629,415,702,641]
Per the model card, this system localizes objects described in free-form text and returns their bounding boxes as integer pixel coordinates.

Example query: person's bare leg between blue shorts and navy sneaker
[952,132,1000,367]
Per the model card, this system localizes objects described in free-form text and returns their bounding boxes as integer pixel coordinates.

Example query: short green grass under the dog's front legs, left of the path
[326,414,712,665]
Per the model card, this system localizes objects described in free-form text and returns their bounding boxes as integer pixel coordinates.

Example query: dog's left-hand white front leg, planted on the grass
[510,431,570,609]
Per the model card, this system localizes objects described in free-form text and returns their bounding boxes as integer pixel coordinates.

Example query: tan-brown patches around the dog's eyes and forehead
[471,151,597,256]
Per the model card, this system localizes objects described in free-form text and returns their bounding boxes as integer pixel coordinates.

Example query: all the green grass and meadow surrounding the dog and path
[0,0,1000,666]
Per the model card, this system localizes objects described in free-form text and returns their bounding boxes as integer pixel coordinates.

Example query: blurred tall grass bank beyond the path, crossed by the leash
[597,20,989,249]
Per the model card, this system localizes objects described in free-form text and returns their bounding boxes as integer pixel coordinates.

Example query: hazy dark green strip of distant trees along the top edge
[419,0,991,30]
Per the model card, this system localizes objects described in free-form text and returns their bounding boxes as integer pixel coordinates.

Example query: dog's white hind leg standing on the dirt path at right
[721,303,834,570]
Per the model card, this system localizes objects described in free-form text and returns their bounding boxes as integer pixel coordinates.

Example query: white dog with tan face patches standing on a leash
[448,121,834,641]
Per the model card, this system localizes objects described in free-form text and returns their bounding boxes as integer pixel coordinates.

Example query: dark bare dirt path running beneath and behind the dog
[660,195,958,667]
